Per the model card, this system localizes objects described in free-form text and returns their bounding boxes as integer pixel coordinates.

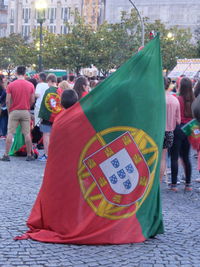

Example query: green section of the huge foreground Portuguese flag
[80,36,166,237]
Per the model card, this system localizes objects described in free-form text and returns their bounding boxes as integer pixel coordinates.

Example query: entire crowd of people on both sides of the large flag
[0,66,200,192]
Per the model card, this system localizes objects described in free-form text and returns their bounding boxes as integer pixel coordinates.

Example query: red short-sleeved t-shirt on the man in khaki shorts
[7,80,35,112]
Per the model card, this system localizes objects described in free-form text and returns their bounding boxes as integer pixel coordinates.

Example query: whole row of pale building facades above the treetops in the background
[5,0,200,37]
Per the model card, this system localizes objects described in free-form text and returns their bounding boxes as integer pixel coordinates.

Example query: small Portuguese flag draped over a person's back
[38,86,62,122]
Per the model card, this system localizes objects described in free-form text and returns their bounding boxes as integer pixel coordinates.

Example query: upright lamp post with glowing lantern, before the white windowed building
[35,0,47,72]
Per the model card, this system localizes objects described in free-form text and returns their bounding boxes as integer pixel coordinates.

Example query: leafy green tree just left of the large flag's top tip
[95,10,140,75]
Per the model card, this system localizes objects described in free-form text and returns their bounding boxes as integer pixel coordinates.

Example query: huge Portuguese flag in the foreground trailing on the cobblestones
[18,36,165,244]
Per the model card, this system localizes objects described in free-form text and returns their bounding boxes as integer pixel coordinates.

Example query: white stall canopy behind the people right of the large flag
[168,58,200,79]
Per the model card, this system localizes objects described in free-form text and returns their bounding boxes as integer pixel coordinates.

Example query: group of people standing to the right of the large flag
[160,75,200,192]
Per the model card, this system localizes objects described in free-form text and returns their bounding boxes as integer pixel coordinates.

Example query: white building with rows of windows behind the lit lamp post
[7,0,82,38]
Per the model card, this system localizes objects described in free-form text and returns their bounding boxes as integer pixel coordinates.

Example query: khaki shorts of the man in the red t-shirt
[8,110,31,136]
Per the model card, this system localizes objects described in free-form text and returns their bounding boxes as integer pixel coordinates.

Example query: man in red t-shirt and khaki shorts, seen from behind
[1,66,35,161]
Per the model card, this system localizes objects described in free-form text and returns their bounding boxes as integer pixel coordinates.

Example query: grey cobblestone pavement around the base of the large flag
[0,140,200,267]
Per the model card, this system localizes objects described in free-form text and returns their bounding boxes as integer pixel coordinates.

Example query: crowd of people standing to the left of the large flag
[0,66,99,161]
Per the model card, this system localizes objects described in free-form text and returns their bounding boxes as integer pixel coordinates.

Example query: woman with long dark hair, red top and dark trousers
[170,77,194,192]
